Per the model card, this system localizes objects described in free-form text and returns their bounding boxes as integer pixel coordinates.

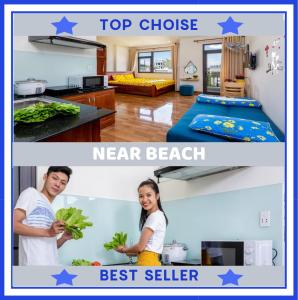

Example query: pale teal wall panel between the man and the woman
[54,196,140,265]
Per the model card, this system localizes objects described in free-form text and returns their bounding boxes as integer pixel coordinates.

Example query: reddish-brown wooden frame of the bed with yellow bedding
[107,72,175,97]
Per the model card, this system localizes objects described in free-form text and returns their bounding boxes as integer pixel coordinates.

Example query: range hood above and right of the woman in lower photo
[154,166,244,180]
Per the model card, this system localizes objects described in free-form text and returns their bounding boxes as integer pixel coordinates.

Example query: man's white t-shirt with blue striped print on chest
[15,188,59,266]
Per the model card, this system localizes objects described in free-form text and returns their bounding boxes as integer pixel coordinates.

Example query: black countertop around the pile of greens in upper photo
[14,96,115,142]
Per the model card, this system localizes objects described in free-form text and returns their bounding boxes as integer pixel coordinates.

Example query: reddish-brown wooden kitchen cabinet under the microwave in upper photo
[62,88,115,129]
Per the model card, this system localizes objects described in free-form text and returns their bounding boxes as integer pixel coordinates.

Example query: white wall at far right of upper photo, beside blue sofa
[246,36,285,132]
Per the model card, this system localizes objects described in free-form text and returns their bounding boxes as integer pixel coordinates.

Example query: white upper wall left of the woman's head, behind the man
[37,166,157,201]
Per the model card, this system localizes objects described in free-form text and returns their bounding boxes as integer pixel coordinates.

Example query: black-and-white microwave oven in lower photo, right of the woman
[201,240,272,266]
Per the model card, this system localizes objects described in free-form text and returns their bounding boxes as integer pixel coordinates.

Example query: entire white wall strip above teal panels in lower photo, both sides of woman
[37,166,284,201]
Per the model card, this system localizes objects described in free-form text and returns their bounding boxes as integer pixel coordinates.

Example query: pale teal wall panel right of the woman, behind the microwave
[163,184,284,265]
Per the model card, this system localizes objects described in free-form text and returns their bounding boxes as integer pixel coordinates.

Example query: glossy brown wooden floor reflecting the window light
[101,92,195,142]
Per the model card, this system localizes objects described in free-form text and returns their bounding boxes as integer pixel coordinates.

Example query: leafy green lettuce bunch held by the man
[56,207,93,240]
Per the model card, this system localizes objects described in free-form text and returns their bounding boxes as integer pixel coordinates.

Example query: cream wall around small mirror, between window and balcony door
[178,37,221,92]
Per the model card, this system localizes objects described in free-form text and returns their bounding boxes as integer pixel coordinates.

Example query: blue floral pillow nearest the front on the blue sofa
[189,114,279,142]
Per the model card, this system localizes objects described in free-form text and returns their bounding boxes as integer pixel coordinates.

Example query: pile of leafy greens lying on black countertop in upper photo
[14,102,80,123]
